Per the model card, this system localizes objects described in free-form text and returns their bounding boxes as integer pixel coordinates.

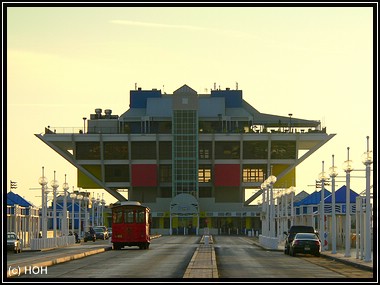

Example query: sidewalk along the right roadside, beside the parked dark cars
[249,237,373,272]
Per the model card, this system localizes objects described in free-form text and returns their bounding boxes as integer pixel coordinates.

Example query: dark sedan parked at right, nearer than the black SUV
[289,233,321,256]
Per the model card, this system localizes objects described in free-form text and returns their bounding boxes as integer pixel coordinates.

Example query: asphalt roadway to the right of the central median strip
[214,236,373,282]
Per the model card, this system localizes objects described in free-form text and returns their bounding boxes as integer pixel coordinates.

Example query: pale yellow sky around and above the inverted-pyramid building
[6,7,374,205]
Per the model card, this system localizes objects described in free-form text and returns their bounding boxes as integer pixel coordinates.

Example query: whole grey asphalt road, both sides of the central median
[7,236,373,282]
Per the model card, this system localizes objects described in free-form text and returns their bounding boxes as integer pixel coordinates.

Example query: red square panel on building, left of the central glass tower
[132,164,157,186]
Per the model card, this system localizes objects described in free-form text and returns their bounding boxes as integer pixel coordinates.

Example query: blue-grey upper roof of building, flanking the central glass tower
[120,84,320,127]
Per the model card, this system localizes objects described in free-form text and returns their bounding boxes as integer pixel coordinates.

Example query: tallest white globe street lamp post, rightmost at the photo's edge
[362,136,373,262]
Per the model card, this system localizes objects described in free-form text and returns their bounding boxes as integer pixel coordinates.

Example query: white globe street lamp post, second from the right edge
[343,147,353,257]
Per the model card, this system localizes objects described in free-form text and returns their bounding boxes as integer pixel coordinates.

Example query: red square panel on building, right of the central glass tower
[214,164,240,186]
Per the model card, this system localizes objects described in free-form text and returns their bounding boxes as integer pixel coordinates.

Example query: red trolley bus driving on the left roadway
[111,201,151,250]
